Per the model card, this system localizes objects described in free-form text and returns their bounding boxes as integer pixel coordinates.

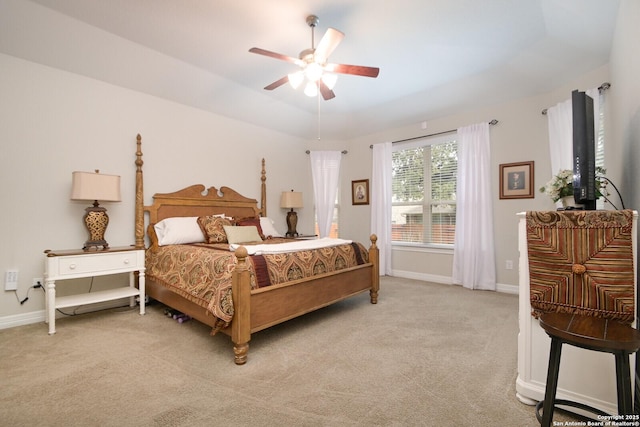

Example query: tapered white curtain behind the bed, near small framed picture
[310,151,342,238]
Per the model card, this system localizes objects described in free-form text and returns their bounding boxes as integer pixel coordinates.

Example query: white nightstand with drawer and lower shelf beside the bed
[44,246,145,335]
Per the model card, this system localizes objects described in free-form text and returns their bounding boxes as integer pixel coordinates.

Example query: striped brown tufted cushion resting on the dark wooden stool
[527,210,635,322]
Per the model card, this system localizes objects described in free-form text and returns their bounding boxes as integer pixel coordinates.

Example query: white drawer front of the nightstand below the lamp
[52,251,138,278]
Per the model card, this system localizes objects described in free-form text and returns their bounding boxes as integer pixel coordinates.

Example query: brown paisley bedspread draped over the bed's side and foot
[146,239,369,324]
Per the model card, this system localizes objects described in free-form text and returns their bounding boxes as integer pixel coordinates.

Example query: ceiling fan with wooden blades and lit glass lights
[249,15,380,100]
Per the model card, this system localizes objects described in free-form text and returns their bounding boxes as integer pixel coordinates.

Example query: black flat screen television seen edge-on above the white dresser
[571,90,597,210]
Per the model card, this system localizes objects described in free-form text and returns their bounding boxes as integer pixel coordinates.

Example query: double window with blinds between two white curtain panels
[391,134,458,246]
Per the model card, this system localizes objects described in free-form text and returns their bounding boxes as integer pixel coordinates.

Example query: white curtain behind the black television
[544,88,600,176]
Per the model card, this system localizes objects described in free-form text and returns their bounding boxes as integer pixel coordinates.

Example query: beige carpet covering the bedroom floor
[0,277,571,426]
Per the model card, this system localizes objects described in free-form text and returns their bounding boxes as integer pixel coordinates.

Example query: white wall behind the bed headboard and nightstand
[0,54,313,318]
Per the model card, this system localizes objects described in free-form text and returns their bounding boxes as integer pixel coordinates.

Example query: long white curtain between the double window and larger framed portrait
[452,123,496,290]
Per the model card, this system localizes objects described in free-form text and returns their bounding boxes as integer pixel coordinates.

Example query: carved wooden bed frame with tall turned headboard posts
[135,135,379,365]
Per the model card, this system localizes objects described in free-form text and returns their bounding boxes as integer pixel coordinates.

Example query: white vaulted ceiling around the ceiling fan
[0,0,619,139]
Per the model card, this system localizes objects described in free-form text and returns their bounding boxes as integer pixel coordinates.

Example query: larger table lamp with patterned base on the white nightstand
[71,169,120,251]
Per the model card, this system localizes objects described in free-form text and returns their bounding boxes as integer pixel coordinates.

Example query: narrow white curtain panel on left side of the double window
[371,142,392,276]
